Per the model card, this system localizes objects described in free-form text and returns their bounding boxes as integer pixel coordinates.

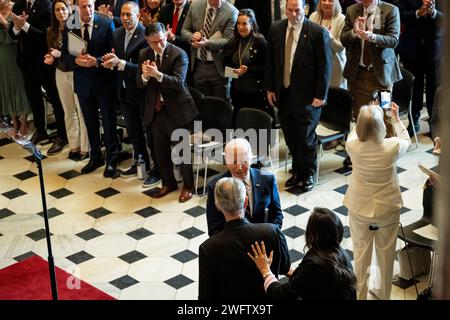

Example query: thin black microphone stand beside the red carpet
[0,120,58,300]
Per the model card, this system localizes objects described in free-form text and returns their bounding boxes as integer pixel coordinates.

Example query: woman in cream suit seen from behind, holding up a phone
[344,103,411,299]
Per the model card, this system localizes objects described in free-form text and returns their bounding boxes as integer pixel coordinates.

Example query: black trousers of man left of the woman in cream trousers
[23,65,67,140]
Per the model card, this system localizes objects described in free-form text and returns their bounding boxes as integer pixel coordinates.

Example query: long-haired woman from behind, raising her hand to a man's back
[248,208,356,300]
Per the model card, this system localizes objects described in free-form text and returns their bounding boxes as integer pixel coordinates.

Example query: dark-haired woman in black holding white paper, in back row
[225,9,273,121]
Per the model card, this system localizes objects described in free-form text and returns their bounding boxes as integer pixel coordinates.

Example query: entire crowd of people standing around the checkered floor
[0,0,443,299]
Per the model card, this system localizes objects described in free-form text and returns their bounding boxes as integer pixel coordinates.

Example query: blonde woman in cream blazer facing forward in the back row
[309,0,347,89]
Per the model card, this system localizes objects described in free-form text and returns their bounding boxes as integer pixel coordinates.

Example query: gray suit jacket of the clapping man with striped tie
[181,0,239,77]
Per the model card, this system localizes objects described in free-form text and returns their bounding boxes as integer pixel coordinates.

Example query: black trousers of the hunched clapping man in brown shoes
[151,106,194,188]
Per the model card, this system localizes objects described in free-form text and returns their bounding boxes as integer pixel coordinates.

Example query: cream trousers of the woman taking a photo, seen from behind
[349,211,400,300]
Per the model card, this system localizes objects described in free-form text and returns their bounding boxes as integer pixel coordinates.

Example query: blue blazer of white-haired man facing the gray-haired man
[206,168,283,236]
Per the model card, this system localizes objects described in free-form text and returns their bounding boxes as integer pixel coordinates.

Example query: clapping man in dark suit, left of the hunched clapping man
[102,1,160,187]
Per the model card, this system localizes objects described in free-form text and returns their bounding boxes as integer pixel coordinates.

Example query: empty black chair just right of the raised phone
[392,68,418,148]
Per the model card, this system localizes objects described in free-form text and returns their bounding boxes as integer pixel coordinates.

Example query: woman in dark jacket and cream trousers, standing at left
[44,0,89,161]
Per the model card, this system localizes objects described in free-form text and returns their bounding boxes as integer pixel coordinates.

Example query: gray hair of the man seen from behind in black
[214,178,247,214]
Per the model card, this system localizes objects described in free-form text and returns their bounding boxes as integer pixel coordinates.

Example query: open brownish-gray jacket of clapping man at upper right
[341,1,402,86]
